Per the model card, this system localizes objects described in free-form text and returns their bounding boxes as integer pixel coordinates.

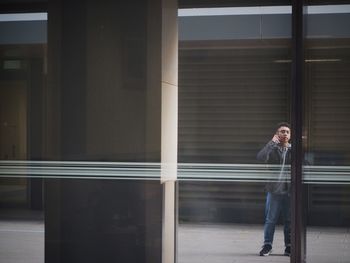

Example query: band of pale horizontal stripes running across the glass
[0,161,350,184]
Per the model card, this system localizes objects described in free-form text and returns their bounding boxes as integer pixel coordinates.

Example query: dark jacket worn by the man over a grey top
[257,141,291,194]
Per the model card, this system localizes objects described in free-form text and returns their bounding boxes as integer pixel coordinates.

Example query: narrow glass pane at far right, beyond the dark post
[304,1,350,263]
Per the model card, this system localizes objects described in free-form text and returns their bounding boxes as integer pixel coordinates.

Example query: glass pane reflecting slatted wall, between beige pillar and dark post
[178,3,291,263]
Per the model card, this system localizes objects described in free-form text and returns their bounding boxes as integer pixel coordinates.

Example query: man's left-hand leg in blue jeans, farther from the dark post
[264,192,281,246]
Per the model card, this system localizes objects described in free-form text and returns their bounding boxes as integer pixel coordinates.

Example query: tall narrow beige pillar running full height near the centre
[161,0,178,263]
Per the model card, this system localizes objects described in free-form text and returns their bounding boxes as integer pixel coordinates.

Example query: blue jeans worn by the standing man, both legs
[264,192,290,249]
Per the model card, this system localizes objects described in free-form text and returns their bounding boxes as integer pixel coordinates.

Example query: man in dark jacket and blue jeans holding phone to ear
[257,122,291,256]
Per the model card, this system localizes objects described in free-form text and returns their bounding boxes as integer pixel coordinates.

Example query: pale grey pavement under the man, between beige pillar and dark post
[178,224,290,263]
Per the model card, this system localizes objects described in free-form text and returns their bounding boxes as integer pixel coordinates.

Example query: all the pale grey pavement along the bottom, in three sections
[0,219,350,263]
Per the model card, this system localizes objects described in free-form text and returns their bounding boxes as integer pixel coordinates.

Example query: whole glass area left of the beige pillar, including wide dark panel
[0,1,167,263]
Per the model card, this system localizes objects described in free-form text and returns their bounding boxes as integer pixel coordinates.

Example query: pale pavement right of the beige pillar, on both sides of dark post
[178,224,350,263]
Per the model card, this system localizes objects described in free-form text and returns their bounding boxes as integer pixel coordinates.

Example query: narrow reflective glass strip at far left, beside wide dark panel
[0,13,47,263]
